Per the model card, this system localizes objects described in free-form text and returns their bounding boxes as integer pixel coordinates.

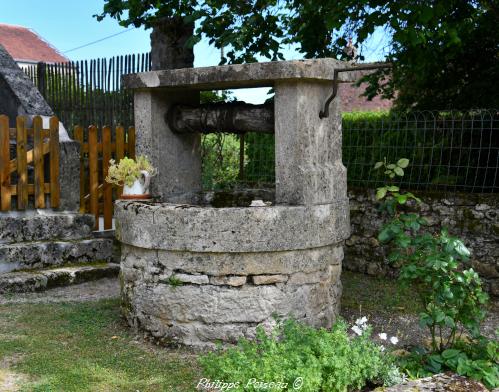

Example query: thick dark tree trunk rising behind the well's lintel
[151,18,194,71]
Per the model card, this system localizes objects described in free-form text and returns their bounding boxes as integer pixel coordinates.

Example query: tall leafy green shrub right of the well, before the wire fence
[375,159,487,352]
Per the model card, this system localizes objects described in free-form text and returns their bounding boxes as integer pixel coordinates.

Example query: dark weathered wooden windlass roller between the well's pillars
[167,102,274,133]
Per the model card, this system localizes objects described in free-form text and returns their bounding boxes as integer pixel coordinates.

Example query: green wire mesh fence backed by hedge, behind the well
[203,110,499,193]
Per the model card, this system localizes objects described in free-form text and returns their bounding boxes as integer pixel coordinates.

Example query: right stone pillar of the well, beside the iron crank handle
[275,80,347,205]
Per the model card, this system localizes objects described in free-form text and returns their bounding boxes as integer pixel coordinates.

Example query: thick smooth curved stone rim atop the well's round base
[115,199,349,252]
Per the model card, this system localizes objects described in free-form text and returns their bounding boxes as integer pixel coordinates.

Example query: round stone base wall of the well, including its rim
[115,200,350,346]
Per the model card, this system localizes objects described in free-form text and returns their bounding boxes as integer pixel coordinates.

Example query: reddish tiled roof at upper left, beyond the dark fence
[0,23,69,63]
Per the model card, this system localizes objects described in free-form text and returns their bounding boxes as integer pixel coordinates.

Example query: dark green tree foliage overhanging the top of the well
[97,0,499,109]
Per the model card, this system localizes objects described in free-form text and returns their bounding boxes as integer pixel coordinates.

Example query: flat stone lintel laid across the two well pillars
[123,58,355,90]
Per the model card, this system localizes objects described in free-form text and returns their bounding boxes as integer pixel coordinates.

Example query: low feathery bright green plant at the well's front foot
[200,320,401,392]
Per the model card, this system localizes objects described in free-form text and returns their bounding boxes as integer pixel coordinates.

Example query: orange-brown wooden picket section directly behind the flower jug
[74,125,135,230]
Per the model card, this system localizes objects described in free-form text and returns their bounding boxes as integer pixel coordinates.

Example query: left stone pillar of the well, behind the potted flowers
[135,90,202,203]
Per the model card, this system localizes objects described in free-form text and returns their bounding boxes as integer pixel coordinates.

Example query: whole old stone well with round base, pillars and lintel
[115,59,349,346]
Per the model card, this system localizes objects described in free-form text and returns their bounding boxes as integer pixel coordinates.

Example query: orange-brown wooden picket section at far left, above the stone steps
[0,115,60,211]
